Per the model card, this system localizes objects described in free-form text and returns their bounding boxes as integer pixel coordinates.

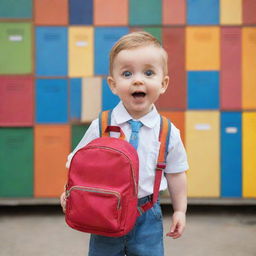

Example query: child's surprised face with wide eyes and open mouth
[108,45,169,119]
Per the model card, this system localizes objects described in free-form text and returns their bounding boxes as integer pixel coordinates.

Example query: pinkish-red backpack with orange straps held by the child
[66,111,170,237]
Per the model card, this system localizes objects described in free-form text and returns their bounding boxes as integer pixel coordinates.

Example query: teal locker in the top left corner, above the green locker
[0,0,32,19]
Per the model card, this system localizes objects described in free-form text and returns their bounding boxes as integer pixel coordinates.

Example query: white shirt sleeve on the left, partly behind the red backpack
[66,119,99,168]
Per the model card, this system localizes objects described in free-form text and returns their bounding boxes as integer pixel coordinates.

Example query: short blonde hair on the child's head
[109,31,168,75]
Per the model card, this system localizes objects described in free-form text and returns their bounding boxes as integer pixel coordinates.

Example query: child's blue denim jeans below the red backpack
[88,197,164,256]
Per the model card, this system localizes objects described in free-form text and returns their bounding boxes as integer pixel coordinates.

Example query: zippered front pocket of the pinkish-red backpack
[67,186,121,232]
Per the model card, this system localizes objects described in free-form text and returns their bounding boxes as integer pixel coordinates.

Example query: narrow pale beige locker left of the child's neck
[81,77,102,122]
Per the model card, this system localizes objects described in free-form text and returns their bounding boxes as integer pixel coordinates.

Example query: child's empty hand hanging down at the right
[166,212,186,239]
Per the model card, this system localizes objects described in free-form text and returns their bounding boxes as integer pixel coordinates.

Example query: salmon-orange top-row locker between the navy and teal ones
[93,0,128,26]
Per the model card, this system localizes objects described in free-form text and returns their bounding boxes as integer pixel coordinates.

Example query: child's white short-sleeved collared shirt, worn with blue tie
[66,102,189,198]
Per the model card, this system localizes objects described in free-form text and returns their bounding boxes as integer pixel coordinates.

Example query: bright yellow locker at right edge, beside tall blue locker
[243,112,256,197]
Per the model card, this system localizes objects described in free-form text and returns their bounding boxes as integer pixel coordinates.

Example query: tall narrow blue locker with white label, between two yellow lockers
[221,112,242,197]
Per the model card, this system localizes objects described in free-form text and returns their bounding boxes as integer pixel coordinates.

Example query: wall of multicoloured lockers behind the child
[0,0,256,200]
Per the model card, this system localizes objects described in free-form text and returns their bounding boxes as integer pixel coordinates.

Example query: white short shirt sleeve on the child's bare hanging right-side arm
[165,124,189,173]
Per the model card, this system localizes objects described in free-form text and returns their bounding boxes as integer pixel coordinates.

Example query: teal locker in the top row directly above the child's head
[129,0,162,26]
